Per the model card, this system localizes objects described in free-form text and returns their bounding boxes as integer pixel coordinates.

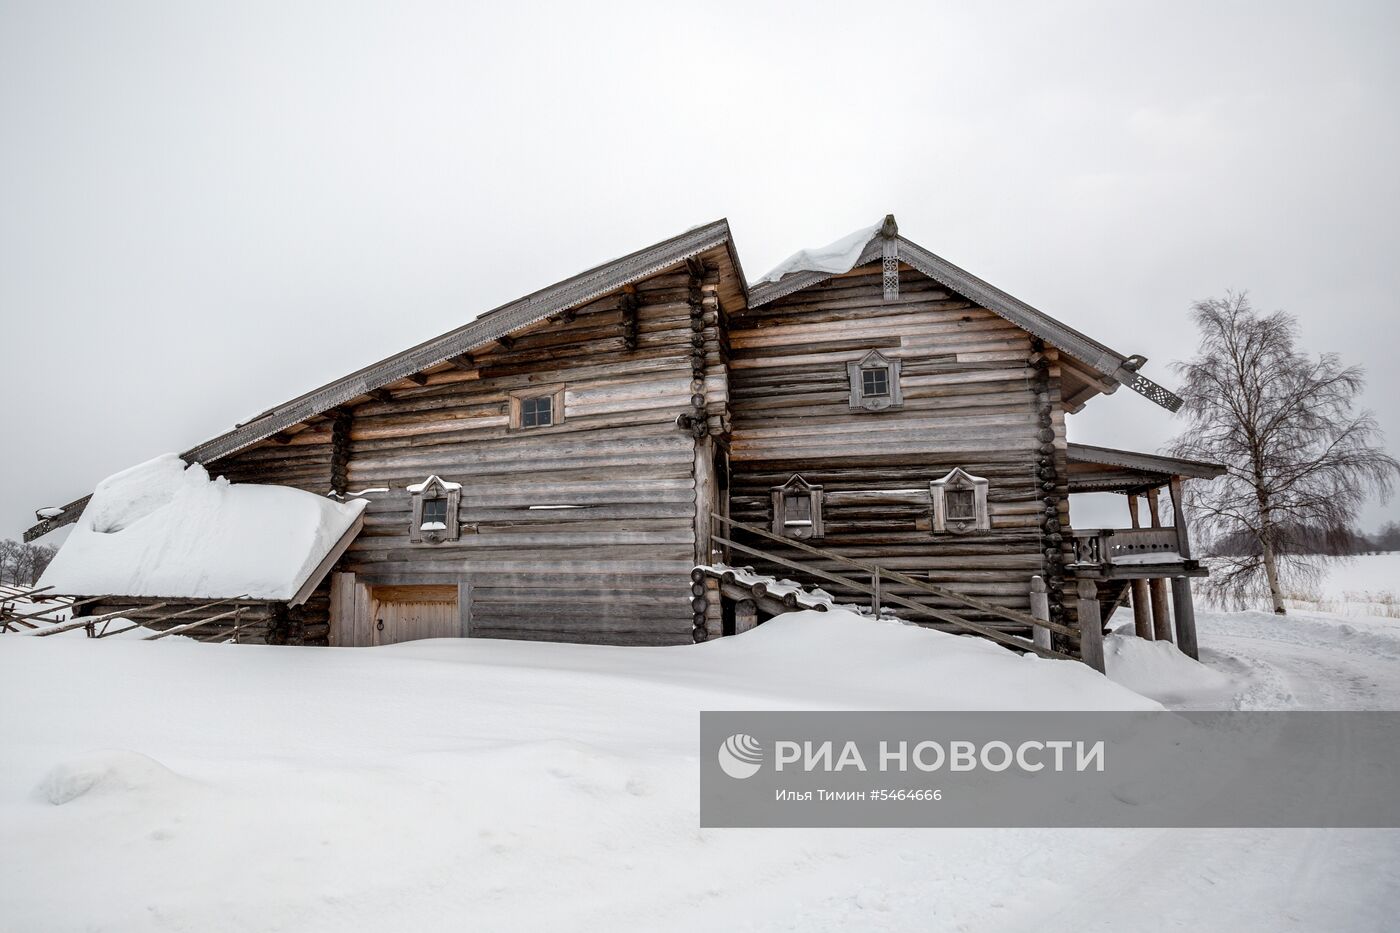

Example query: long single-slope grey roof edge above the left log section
[24,217,743,541]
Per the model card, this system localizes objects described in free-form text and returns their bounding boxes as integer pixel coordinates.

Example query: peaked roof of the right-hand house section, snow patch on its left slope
[749,214,1182,412]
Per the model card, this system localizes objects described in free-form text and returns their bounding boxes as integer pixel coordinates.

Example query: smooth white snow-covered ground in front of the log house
[0,560,1400,933]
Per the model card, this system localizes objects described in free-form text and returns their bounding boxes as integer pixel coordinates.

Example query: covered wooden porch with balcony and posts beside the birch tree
[1067,444,1225,658]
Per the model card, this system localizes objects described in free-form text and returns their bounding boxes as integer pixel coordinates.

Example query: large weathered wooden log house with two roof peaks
[27,217,1218,668]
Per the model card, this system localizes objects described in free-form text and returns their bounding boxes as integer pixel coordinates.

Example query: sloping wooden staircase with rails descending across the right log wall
[711,516,1079,660]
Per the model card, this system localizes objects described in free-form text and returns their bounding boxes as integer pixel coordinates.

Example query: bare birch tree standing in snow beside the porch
[1172,293,1400,615]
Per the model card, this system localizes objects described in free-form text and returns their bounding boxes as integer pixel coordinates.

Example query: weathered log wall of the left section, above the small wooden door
[210,259,728,644]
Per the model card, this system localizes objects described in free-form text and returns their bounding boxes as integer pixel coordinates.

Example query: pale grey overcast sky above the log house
[0,1,1400,539]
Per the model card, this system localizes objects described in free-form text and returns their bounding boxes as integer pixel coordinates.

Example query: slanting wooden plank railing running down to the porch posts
[711,516,1079,660]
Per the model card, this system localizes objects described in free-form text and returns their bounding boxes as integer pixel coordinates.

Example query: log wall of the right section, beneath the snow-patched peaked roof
[729,266,1068,618]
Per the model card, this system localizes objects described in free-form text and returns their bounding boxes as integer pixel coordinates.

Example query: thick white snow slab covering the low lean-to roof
[39,454,367,600]
